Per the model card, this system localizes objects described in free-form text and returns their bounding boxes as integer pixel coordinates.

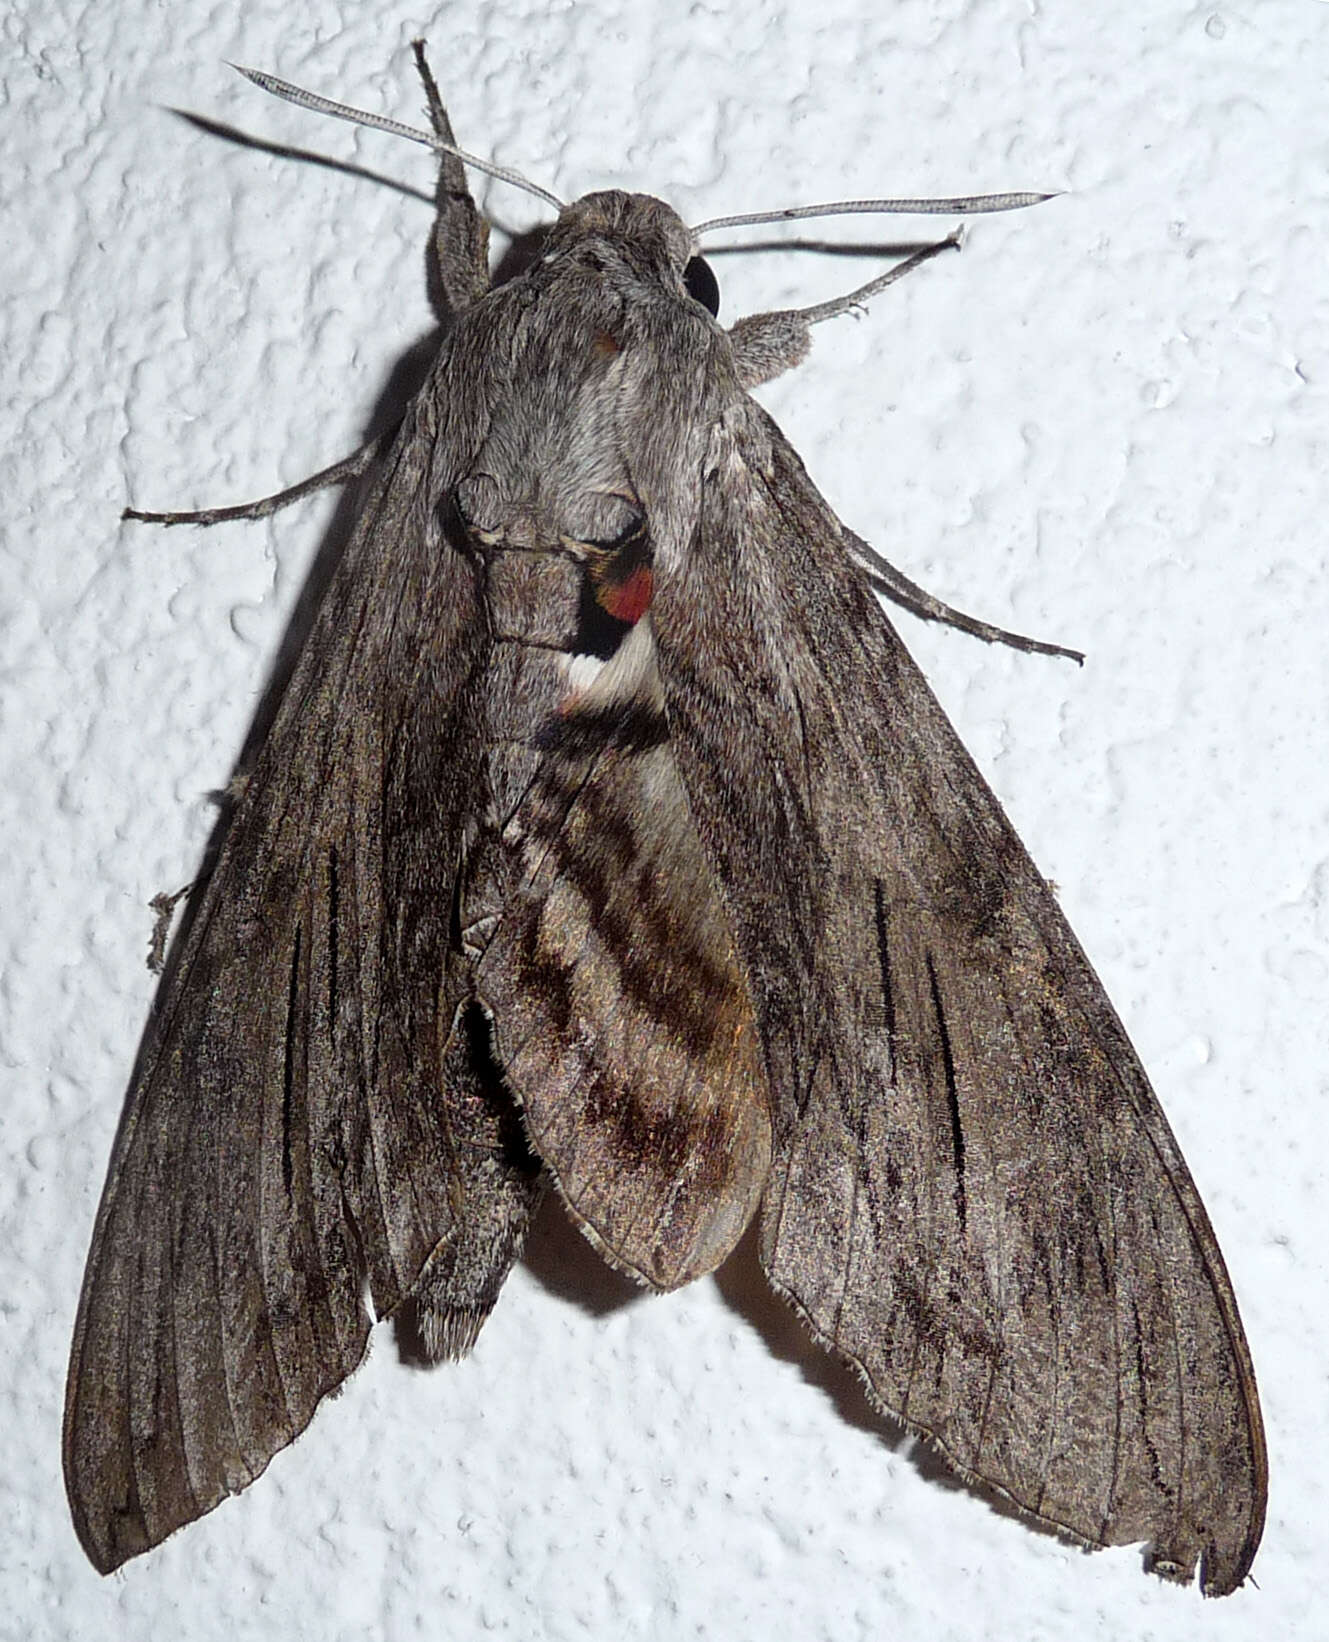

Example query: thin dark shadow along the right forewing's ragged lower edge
[713,1223,1066,1543]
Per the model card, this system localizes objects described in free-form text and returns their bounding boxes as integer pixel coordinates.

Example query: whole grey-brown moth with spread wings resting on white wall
[64,53,1267,1594]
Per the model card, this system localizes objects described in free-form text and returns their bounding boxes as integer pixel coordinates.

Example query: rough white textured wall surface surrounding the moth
[0,0,1329,1642]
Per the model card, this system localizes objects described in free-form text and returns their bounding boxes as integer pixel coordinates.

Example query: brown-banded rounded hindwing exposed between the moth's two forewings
[476,621,770,1289]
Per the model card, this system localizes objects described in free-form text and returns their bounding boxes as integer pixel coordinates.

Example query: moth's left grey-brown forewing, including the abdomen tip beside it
[64,315,531,1570]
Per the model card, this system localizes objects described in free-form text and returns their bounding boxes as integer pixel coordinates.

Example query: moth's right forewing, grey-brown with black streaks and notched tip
[652,401,1265,1593]
